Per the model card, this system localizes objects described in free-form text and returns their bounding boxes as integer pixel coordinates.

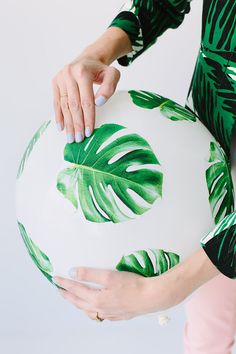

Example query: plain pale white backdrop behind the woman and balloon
[0,0,234,354]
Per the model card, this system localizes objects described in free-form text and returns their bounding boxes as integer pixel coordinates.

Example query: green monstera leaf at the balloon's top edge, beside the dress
[128,90,197,122]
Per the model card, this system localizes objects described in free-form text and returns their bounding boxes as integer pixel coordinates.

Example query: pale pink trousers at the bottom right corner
[184,274,236,354]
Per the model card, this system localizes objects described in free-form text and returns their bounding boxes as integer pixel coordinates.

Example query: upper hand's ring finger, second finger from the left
[58,82,75,144]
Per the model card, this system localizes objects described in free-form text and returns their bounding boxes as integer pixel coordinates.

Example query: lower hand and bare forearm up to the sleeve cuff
[53,248,220,321]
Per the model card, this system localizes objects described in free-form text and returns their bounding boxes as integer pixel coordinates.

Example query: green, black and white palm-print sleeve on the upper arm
[108,0,191,66]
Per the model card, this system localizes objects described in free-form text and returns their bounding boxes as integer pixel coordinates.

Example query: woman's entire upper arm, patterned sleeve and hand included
[52,0,192,143]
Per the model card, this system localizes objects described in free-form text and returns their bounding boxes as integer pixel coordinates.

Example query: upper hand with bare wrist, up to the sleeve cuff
[52,27,132,143]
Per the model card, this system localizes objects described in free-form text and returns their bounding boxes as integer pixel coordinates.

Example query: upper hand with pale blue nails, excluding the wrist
[52,49,120,143]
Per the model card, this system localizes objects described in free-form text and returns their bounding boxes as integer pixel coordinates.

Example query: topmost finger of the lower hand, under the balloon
[70,267,118,286]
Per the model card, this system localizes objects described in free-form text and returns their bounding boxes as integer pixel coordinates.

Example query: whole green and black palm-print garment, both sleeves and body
[108,0,236,278]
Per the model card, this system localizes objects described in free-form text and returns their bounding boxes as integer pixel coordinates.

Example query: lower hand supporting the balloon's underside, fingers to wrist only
[53,267,150,321]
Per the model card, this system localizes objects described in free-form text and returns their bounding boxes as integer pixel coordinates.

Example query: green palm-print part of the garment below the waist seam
[188,48,236,156]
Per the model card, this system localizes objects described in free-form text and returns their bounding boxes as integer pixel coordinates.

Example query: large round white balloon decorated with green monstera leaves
[17,90,233,290]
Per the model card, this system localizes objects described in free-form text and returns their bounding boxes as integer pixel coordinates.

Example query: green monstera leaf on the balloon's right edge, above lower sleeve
[206,142,234,224]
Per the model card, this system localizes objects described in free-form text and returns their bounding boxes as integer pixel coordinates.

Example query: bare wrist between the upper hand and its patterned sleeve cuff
[80,27,132,65]
